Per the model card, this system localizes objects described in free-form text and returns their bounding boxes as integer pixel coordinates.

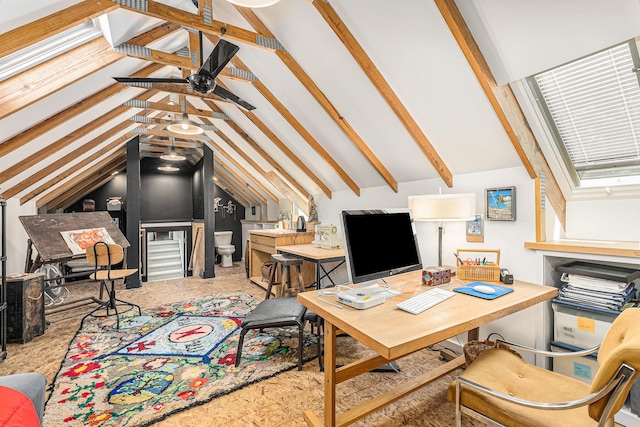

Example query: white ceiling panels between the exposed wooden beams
[0,0,640,208]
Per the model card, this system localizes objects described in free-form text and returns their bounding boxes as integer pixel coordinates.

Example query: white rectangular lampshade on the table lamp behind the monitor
[409,193,476,222]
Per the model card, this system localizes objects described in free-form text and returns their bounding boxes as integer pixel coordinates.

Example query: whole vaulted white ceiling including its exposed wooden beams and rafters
[0,0,632,219]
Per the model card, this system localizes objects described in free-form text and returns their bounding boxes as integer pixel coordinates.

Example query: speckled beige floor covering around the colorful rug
[0,264,478,427]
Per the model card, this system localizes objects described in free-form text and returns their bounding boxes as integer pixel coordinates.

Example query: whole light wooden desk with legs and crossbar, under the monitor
[298,271,557,426]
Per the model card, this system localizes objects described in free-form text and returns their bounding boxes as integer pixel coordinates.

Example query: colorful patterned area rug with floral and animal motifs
[44,293,316,426]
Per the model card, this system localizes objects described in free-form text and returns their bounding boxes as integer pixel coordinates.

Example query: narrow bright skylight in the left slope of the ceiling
[0,21,102,81]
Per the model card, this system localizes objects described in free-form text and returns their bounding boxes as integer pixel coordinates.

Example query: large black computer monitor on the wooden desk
[342,209,422,283]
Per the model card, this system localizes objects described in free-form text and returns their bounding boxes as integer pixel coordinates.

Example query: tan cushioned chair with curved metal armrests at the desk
[447,308,640,427]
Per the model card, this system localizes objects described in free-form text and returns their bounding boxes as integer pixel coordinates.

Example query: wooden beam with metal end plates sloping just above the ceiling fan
[112,0,281,51]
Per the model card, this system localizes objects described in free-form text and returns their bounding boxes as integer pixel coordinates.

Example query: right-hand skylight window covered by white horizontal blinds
[528,42,640,187]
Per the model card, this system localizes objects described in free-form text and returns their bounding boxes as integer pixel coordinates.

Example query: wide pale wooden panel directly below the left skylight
[0,37,124,119]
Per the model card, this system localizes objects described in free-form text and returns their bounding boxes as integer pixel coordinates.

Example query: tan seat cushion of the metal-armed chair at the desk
[447,349,597,427]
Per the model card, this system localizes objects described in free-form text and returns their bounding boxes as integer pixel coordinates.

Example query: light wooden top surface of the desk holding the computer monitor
[298,271,558,360]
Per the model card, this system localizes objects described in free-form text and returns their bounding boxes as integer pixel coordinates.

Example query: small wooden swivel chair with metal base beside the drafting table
[82,242,142,329]
